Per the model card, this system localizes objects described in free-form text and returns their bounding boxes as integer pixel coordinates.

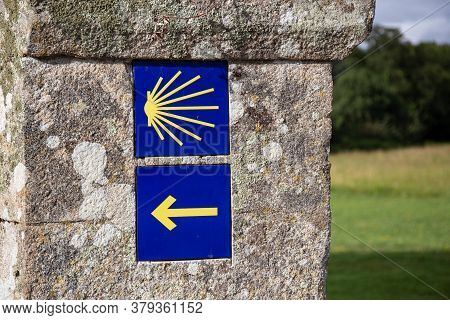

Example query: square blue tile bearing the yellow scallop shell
[133,61,229,157]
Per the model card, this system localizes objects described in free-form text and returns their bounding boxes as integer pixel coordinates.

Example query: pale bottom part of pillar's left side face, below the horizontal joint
[0,222,18,300]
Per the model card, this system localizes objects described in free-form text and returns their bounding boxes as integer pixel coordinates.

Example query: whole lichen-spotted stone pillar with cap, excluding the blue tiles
[0,0,374,299]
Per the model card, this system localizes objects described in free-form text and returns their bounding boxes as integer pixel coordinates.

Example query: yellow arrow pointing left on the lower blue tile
[152,196,218,231]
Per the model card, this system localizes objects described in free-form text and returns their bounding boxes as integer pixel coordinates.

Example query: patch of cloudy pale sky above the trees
[375,0,450,44]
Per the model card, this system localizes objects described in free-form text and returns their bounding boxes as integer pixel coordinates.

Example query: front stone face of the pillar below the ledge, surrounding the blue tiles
[4,58,332,299]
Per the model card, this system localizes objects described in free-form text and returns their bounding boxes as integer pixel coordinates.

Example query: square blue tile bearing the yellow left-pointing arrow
[136,164,231,261]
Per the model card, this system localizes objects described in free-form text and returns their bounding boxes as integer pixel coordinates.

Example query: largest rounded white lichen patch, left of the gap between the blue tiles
[72,142,108,195]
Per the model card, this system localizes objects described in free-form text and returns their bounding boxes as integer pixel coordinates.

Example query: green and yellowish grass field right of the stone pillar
[327,144,450,299]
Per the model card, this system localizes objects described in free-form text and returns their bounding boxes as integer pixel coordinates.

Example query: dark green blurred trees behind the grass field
[332,27,450,151]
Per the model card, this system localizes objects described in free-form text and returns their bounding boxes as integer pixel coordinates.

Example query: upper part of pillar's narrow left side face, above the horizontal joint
[0,1,26,225]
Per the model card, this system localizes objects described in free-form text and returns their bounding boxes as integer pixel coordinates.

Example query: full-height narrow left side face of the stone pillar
[0,0,27,299]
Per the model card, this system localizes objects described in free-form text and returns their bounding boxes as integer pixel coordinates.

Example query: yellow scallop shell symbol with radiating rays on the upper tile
[144,71,219,146]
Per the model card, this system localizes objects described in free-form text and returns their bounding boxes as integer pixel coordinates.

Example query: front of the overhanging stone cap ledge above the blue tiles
[17,0,374,60]
